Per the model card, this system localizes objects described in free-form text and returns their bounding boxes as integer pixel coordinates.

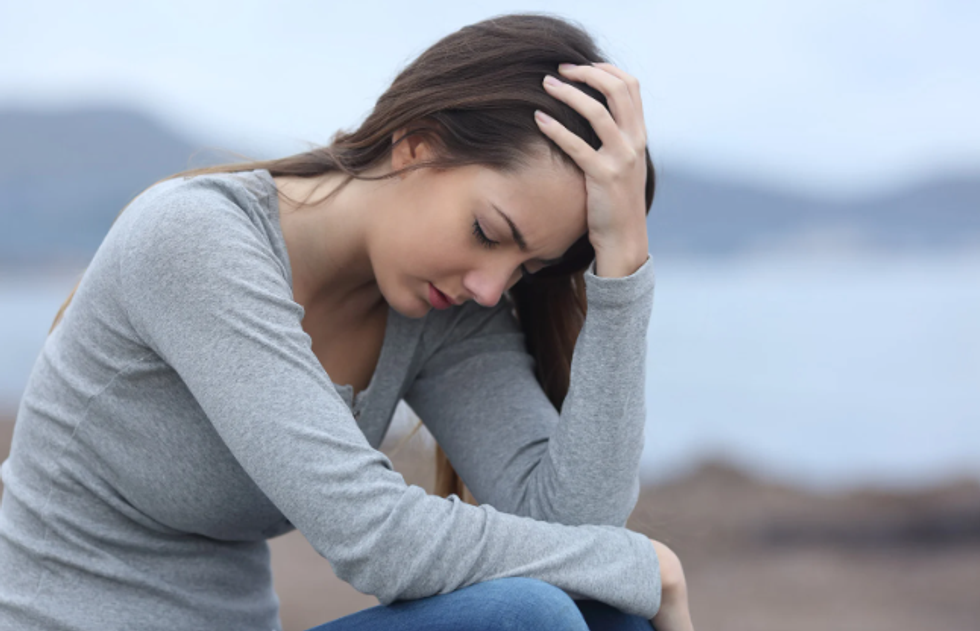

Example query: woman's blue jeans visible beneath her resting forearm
[308,577,653,631]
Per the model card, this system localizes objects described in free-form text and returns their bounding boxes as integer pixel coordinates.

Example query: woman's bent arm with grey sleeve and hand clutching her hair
[407,63,653,526]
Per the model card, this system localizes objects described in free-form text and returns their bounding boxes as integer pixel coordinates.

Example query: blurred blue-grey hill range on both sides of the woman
[0,109,980,266]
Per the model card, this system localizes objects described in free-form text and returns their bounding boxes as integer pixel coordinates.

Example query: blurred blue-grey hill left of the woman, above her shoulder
[0,109,245,266]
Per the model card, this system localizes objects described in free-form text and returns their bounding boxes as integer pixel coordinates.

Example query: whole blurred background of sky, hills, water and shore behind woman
[0,0,980,630]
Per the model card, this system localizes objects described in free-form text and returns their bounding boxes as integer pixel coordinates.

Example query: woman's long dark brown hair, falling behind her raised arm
[51,13,654,504]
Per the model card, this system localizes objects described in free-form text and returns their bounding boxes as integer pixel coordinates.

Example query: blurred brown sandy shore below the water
[0,420,980,631]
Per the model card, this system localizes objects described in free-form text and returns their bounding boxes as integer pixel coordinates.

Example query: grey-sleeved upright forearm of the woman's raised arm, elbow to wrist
[526,254,654,526]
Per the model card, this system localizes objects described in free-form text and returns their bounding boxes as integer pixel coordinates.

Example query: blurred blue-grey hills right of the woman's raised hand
[648,172,980,257]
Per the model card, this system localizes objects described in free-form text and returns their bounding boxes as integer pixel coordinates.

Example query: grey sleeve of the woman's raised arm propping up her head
[406,258,654,526]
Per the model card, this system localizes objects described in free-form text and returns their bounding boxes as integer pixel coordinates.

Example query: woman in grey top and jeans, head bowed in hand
[0,15,691,631]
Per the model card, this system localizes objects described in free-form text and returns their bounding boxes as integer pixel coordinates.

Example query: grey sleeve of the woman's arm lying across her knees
[116,191,660,618]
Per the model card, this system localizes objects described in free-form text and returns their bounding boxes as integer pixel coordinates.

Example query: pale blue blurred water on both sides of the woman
[0,253,980,488]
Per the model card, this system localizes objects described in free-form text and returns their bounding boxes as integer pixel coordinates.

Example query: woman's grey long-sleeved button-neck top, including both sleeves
[0,170,660,631]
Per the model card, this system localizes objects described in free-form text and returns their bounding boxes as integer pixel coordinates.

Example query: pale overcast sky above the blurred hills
[0,0,980,195]
